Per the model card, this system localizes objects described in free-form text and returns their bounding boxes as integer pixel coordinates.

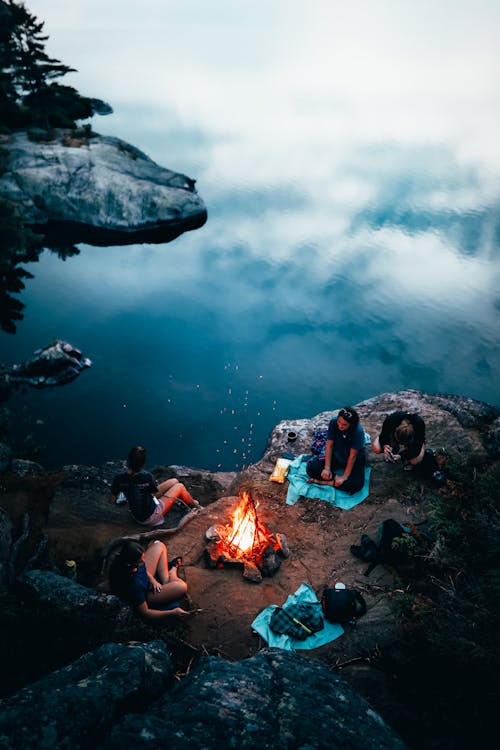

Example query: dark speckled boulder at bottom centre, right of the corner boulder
[103,649,406,750]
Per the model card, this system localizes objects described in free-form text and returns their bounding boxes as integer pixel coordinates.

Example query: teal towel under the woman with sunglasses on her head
[286,454,371,510]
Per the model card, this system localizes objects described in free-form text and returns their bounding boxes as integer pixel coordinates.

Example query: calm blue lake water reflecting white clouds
[0,0,500,470]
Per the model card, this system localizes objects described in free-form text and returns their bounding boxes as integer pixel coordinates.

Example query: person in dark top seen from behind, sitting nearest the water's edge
[111,445,201,526]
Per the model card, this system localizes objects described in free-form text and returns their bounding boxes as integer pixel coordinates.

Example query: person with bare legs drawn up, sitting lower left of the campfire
[109,540,190,620]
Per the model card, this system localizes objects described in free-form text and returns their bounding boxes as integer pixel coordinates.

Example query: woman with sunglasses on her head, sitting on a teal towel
[307,406,366,494]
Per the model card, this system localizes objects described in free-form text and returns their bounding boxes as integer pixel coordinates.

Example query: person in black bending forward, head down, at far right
[373,411,425,470]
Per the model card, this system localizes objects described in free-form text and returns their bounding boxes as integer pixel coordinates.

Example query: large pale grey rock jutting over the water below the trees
[0,131,207,245]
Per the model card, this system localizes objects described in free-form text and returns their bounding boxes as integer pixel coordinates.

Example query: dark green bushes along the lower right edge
[389,461,500,748]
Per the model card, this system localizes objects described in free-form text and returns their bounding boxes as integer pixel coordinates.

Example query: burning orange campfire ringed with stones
[205,491,289,583]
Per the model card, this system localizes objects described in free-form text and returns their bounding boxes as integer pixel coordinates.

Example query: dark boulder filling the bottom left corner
[0,641,173,750]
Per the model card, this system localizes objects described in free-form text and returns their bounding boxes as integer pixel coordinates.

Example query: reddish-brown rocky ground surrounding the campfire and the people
[2,391,500,748]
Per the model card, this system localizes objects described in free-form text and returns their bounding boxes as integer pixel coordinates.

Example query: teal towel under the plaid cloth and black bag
[250,583,344,651]
